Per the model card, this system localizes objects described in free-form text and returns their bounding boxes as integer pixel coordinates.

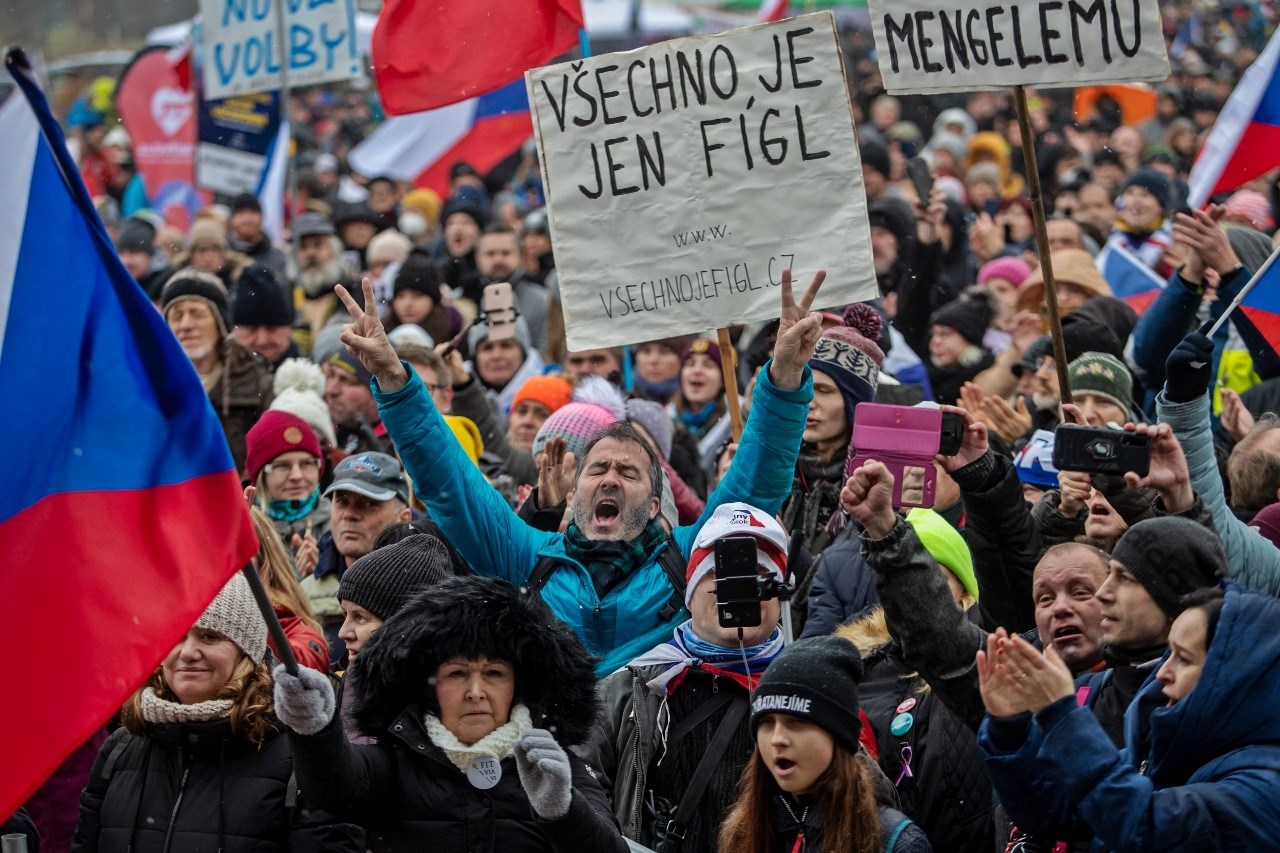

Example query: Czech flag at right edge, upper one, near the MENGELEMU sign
[1187,31,1280,207]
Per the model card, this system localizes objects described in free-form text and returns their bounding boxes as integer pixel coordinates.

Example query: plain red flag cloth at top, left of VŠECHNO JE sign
[372,0,584,115]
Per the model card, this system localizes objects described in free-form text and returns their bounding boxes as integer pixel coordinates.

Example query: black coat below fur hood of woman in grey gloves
[289,706,627,853]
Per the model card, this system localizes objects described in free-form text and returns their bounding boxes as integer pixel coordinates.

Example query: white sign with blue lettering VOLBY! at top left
[200,0,362,100]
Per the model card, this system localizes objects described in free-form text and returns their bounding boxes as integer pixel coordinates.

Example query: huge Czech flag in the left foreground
[0,51,257,817]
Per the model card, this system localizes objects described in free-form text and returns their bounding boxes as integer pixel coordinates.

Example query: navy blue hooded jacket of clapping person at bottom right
[979,581,1280,853]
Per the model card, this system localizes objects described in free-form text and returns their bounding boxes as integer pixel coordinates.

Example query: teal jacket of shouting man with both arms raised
[372,362,813,676]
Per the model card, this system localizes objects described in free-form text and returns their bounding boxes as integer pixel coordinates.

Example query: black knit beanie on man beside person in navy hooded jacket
[1111,516,1228,619]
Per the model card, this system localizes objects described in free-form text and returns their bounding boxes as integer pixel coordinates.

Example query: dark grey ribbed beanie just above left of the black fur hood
[338,533,453,621]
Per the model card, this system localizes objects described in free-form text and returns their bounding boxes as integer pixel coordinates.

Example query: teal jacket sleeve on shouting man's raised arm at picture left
[371,364,559,584]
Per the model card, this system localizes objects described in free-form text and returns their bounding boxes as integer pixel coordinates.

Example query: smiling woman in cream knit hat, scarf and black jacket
[72,575,365,853]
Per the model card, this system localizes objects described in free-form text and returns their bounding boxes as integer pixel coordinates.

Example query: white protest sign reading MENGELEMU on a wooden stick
[868,0,1169,95]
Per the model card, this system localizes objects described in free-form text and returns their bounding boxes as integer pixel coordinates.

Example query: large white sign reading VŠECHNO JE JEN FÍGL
[525,13,877,351]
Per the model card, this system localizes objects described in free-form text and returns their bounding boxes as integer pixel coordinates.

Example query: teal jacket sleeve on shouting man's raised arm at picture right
[673,361,813,557]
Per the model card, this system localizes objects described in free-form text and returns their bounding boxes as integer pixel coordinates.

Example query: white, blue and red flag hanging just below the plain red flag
[348,79,534,199]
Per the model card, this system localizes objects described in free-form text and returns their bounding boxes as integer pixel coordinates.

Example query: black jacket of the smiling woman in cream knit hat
[72,720,365,853]
